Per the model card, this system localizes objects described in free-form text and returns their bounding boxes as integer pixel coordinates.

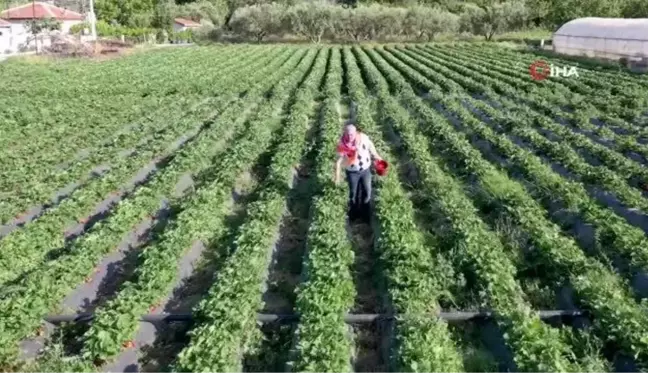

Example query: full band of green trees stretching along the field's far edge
[64,0,648,42]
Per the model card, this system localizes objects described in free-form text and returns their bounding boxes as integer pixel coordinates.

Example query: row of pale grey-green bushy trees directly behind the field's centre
[220,1,527,43]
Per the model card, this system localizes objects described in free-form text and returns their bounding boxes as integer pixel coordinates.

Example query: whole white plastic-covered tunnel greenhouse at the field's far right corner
[552,17,648,60]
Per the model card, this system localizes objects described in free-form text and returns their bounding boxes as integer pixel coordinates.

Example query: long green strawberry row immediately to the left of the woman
[290,48,356,373]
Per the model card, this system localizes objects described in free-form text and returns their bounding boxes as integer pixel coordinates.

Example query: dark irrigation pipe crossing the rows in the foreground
[43,310,586,324]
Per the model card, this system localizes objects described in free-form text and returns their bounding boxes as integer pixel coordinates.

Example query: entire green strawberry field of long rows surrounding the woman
[0,44,648,373]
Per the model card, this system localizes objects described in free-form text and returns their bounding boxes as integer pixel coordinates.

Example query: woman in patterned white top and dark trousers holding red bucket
[334,123,382,219]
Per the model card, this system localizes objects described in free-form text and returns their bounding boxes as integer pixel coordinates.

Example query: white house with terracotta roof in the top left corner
[0,2,85,53]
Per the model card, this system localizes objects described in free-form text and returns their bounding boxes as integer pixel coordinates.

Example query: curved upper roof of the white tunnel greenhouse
[554,17,648,40]
